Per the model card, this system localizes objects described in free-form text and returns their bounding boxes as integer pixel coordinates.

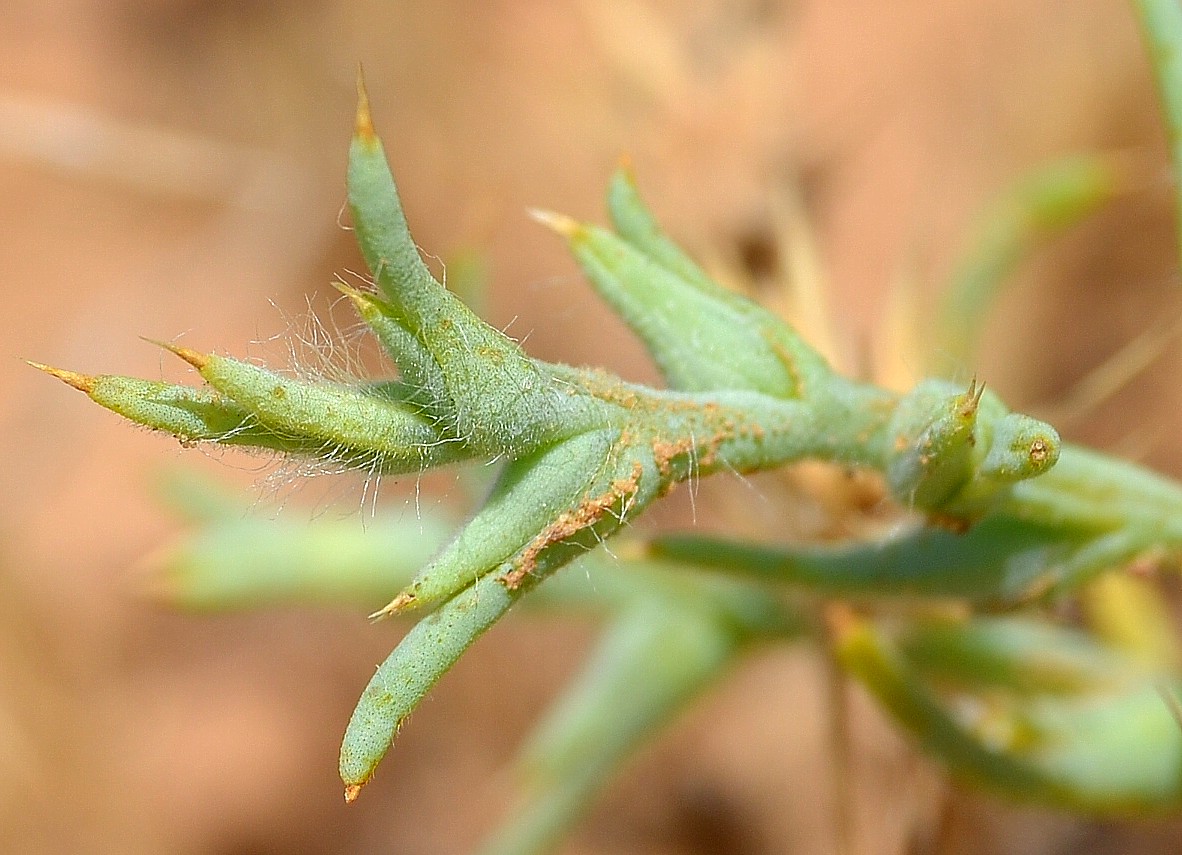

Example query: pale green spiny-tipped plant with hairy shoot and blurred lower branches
[29,51,1182,853]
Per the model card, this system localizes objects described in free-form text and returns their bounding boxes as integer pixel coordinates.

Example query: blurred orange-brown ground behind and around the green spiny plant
[0,0,1182,855]
